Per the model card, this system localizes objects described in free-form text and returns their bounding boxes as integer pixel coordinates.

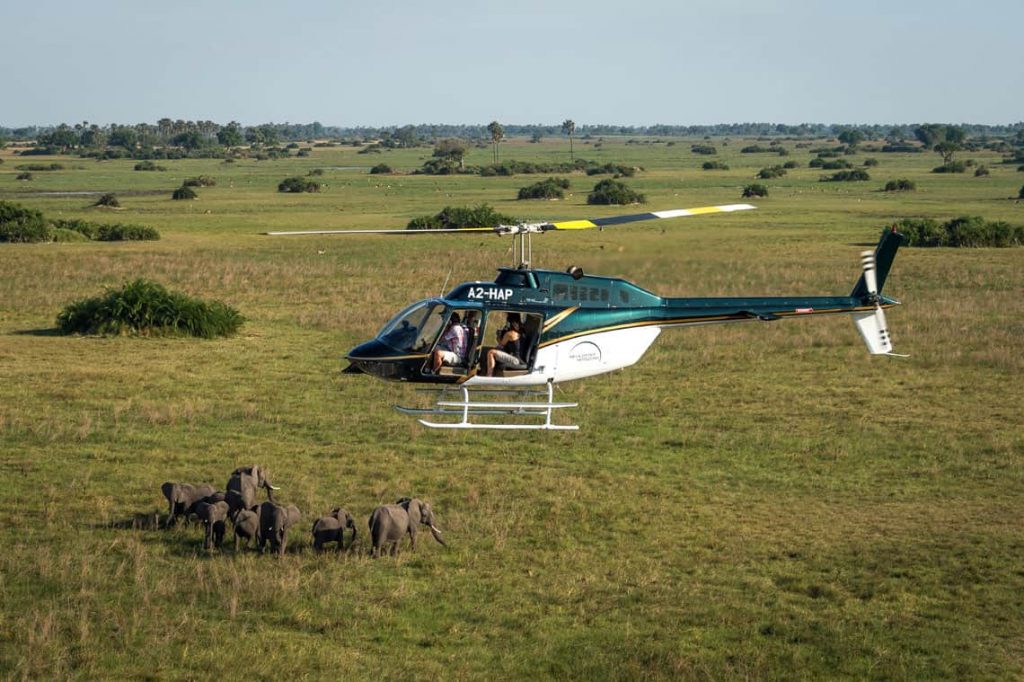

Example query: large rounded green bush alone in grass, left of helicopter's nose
[57,280,245,339]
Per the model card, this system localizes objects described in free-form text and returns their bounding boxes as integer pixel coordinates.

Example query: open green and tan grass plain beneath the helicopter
[0,138,1024,680]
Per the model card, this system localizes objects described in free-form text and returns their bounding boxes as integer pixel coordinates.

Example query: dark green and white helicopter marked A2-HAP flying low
[265,204,903,430]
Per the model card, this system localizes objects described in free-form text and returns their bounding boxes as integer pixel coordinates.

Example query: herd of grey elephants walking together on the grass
[161,466,444,557]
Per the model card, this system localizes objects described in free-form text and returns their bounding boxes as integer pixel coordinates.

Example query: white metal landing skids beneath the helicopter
[395,381,580,431]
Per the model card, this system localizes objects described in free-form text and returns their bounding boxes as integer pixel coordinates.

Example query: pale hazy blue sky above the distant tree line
[0,0,1024,127]
